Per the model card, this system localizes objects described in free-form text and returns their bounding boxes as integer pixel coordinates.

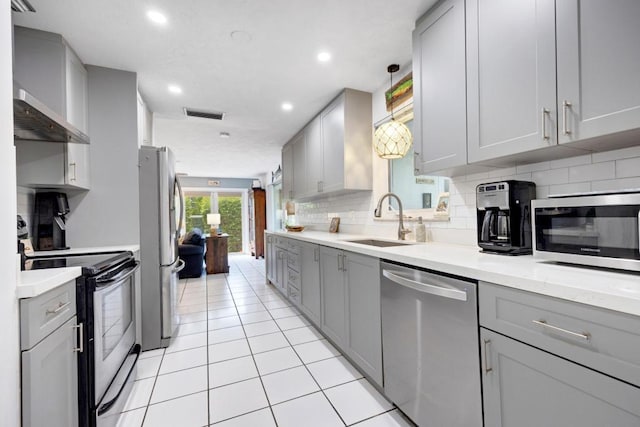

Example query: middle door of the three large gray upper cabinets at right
[467,0,557,163]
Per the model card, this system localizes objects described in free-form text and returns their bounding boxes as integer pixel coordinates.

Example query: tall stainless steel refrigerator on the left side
[138,146,184,350]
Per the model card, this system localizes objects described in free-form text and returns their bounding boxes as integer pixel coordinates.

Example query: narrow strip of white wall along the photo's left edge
[0,0,20,426]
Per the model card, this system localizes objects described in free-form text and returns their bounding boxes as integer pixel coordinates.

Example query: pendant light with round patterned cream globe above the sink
[373,64,413,159]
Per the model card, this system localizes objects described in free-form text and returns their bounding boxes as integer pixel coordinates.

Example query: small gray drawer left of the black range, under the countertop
[20,280,76,350]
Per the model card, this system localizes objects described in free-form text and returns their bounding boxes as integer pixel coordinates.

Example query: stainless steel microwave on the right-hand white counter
[532,192,640,271]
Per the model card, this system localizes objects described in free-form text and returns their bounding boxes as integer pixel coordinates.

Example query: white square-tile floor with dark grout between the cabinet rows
[118,255,411,427]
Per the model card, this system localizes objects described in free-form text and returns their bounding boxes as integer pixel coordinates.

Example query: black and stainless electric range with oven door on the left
[25,251,141,427]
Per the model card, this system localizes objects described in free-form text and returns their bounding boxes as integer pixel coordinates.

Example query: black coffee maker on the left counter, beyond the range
[33,192,69,251]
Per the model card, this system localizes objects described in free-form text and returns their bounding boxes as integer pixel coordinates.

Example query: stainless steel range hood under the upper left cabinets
[13,83,89,144]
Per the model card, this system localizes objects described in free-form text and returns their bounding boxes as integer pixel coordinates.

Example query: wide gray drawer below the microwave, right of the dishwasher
[479,282,640,387]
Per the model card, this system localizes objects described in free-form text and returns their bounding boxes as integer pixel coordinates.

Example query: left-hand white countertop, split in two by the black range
[16,245,140,298]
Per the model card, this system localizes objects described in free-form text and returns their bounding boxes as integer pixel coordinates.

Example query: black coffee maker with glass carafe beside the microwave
[476,180,536,255]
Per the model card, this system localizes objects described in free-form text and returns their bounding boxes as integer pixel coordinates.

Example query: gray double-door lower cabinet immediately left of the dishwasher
[320,247,382,386]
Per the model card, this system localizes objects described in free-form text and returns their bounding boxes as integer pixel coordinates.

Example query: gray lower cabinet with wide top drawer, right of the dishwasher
[478,282,640,427]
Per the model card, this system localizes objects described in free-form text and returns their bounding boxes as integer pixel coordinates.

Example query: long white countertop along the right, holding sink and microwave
[268,231,640,316]
